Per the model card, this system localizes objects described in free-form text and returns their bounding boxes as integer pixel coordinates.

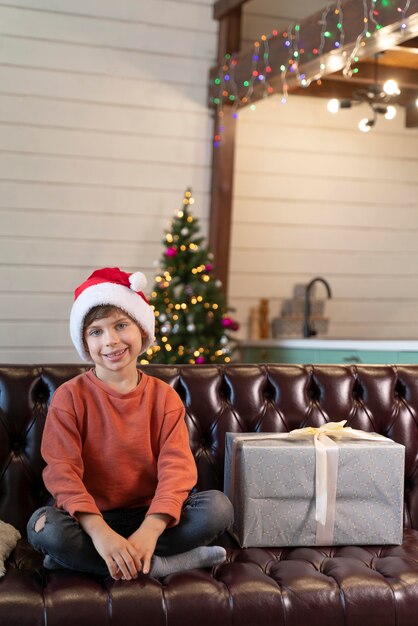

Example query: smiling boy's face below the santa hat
[84,310,142,372]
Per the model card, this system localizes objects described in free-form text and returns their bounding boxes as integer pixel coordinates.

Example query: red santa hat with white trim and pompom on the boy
[70,267,155,361]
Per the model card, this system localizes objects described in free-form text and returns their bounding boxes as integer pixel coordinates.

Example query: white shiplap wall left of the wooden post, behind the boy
[0,0,217,363]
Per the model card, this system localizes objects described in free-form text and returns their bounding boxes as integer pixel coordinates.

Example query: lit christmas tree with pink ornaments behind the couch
[142,190,238,363]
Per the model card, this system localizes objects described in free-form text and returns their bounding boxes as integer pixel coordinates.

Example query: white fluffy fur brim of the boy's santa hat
[70,280,155,361]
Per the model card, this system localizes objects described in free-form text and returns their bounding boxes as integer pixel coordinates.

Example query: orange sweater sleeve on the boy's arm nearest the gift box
[147,400,197,526]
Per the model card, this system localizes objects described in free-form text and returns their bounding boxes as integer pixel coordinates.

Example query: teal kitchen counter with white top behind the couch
[234,339,418,364]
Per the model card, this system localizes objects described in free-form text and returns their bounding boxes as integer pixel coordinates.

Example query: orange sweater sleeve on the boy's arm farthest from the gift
[41,392,101,515]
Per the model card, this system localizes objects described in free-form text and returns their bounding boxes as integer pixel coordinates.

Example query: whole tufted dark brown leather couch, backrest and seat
[0,365,418,626]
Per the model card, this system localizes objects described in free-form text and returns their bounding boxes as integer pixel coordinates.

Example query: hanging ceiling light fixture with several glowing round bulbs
[327,55,400,133]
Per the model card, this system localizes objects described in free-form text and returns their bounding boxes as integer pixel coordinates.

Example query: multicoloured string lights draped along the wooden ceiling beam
[213,0,411,147]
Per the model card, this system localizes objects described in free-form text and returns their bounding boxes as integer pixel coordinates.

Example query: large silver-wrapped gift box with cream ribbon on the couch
[224,422,405,547]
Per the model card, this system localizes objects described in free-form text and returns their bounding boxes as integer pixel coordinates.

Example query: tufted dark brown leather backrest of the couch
[0,365,418,531]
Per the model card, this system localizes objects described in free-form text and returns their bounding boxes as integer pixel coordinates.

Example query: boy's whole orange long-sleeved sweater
[41,371,197,524]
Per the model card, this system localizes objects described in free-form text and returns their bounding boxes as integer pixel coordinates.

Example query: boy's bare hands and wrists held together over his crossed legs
[76,513,172,580]
